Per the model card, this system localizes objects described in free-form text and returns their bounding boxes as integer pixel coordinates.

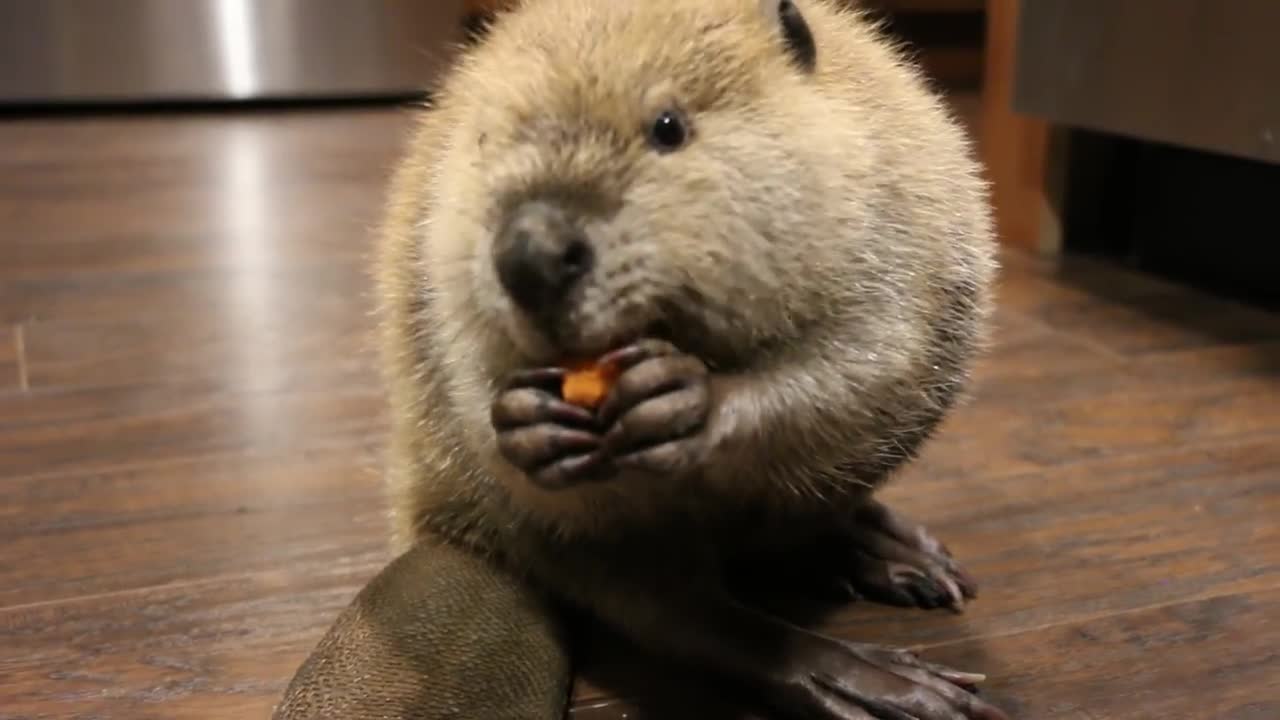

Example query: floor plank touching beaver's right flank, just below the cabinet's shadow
[911,327,1280,489]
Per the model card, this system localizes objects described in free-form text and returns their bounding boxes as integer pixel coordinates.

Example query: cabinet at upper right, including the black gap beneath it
[982,0,1280,304]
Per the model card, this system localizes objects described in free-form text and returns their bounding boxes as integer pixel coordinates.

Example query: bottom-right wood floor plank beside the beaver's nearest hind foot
[572,587,1280,720]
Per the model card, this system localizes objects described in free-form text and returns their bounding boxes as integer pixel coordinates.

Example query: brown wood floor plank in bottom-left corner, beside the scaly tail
[0,562,376,720]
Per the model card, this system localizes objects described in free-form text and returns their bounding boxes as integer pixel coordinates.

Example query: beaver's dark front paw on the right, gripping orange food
[599,340,710,474]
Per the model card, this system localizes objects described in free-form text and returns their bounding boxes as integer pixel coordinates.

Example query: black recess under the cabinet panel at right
[1064,131,1280,309]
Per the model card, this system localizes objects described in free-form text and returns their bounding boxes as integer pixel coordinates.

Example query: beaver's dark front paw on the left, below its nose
[492,368,603,489]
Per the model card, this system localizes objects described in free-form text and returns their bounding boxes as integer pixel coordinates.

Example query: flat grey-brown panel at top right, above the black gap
[1012,0,1280,163]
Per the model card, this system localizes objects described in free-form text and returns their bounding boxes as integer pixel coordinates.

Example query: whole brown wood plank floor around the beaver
[0,96,1280,720]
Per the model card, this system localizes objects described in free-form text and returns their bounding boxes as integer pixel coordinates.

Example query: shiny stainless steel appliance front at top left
[0,0,463,104]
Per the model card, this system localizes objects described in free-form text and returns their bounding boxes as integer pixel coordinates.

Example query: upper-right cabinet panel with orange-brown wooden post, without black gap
[982,0,1280,251]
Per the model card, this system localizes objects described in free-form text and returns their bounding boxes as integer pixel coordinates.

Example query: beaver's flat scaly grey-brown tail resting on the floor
[273,541,571,720]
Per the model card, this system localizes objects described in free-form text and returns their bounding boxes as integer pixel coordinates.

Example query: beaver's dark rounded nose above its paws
[494,201,594,310]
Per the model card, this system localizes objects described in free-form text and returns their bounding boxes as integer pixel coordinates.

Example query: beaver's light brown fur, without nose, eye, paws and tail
[378,0,995,638]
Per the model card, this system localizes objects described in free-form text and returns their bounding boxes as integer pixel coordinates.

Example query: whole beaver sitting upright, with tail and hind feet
[278,0,1005,720]
